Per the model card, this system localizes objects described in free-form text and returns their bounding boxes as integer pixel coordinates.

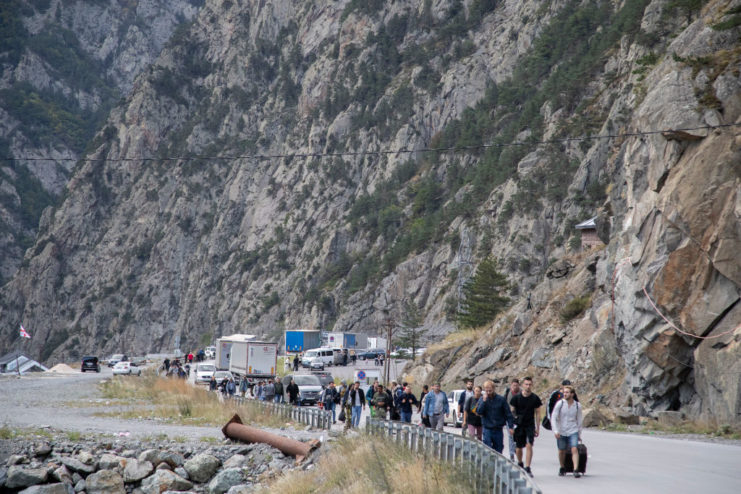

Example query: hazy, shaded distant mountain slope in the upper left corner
[0,0,202,284]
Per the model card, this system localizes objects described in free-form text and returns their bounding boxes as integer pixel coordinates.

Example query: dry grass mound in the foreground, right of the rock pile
[260,436,474,494]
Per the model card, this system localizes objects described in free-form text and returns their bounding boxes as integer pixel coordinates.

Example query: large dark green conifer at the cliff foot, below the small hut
[456,257,509,328]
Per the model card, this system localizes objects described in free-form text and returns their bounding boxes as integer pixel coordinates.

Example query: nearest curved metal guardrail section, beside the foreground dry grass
[365,417,543,494]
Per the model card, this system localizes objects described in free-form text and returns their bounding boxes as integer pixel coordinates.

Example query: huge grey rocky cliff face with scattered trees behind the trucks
[0,0,741,421]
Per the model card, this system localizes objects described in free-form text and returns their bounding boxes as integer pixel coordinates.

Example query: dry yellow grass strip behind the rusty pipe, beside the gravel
[96,374,286,427]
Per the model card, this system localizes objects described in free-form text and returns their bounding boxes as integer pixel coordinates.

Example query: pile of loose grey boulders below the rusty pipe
[0,434,313,494]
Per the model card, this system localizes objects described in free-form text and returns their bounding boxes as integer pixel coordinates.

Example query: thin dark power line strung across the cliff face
[0,123,741,163]
